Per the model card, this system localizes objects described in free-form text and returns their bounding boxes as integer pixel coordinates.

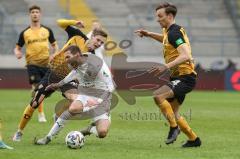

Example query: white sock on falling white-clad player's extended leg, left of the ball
[47,110,73,139]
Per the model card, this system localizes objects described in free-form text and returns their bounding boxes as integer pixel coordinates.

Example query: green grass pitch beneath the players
[0,90,240,159]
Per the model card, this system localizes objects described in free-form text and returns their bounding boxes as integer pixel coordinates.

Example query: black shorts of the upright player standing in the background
[27,65,49,84]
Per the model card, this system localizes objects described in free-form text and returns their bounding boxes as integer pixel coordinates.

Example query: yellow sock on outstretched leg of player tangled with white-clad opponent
[18,105,35,130]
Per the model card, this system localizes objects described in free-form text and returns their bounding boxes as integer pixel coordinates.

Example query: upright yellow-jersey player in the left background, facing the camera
[14,5,58,122]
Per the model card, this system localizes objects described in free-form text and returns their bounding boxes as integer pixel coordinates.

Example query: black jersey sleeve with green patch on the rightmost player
[168,30,186,48]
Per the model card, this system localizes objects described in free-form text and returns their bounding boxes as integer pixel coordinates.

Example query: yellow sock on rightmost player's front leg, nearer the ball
[159,100,177,127]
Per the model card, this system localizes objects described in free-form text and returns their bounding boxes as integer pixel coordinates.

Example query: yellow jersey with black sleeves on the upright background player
[17,25,56,67]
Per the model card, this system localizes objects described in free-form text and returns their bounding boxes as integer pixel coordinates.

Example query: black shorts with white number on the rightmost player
[167,73,197,104]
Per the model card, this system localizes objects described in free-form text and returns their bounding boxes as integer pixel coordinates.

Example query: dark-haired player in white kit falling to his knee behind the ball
[35,46,115,145]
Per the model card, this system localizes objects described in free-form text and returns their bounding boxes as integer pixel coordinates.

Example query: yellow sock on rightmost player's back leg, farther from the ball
[177,117,197,141]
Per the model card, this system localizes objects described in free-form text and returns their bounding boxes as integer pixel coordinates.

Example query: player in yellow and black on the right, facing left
[135,2,201,147]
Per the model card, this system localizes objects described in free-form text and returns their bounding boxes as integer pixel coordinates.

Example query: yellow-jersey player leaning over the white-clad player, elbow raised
[13,19,107,141]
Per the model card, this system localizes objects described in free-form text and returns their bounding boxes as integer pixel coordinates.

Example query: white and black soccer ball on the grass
[65,131,85,149]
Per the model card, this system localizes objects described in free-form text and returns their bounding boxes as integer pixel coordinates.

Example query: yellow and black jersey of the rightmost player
[163,24,196,77]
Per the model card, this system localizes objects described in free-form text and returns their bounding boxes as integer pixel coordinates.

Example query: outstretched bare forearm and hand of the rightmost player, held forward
[134,29,163,43]
